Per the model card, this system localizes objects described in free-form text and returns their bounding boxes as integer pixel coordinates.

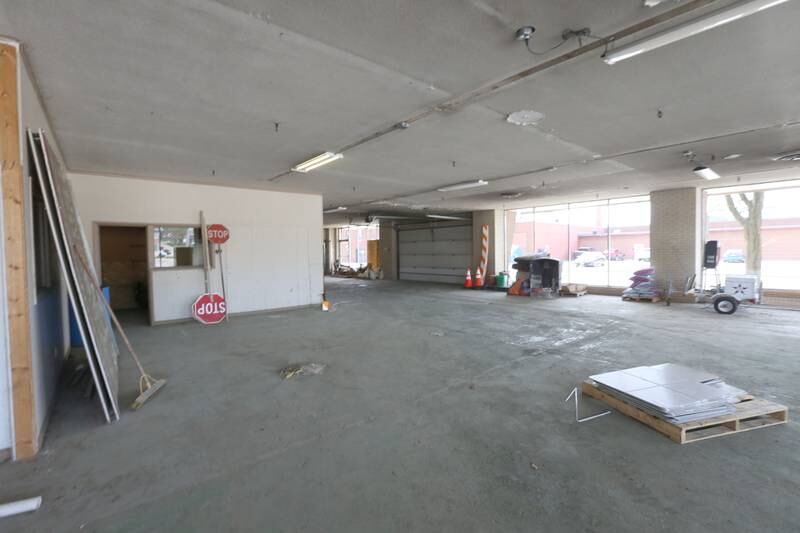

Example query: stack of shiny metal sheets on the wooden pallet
[589,363,747,424]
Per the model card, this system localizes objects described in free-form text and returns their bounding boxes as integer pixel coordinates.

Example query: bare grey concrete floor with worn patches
[0,280,800,533]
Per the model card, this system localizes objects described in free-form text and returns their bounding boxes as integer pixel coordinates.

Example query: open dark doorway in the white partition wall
[100,225,150,323]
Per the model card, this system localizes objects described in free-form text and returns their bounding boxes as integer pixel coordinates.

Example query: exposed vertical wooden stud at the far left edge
[0,43,38,459]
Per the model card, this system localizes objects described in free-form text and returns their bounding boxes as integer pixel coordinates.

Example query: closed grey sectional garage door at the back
[397,225,472,284]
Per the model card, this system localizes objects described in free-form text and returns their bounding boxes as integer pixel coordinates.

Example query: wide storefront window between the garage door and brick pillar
[506,196,650,287]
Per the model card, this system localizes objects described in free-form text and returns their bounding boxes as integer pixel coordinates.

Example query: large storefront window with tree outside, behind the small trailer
[706,182,800,290]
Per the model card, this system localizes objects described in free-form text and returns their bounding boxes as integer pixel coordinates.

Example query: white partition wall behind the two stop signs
[70,174,323,322]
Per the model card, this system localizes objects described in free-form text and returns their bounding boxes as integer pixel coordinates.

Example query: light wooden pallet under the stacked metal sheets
[581,380,789,444]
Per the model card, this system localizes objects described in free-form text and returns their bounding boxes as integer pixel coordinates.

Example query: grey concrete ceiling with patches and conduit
[0,0,800,220]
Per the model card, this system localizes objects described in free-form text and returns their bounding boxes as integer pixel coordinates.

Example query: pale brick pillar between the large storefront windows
[650,188,701,291]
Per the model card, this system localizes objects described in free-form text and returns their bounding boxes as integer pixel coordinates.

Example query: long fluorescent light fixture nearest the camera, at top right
[603,0,789,65]
